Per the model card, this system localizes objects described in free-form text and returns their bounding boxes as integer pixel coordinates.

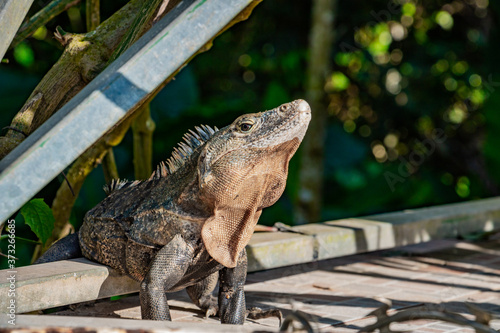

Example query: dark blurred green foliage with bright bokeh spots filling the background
[0,0,500,264]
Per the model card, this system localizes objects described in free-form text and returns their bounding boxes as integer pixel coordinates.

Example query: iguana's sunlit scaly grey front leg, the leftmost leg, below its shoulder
[143,235,193,320]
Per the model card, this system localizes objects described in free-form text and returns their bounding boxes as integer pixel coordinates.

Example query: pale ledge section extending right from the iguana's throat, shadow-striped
[247,198,500,272]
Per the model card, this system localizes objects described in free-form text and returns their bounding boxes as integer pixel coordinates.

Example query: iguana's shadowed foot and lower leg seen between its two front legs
[186,272,219,318]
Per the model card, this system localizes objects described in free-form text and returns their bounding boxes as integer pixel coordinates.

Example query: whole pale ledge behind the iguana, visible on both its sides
[0,198,500,313]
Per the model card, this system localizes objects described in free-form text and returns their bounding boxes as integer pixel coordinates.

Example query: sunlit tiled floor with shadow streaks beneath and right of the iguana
[48,238,500,332]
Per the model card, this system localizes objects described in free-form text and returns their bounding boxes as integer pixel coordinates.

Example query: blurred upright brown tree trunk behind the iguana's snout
[295,0,337,224]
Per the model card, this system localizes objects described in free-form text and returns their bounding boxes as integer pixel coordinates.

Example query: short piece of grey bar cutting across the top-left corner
[0,0,33,60]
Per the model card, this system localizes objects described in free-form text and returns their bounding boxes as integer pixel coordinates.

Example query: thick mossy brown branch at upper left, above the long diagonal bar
[0,0,179,159]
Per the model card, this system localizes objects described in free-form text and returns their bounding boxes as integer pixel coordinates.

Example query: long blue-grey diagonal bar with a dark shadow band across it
[0,0,255,222]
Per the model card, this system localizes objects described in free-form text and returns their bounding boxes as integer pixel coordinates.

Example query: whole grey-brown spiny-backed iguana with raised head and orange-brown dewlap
[37,100,311,324]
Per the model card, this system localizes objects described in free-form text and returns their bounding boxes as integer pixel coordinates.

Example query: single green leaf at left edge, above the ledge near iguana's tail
[21,199,54,244]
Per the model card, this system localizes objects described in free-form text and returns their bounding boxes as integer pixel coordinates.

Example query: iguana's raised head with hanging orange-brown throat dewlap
[198,100,311,267]
